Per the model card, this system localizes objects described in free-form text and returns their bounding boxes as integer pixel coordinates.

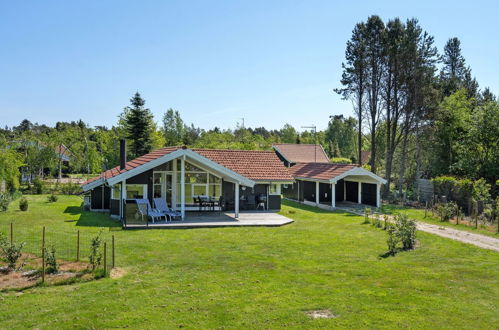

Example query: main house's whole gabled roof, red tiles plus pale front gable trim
[82,147,293,191]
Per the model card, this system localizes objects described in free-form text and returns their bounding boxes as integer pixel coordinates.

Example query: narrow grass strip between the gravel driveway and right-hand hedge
[381,204,499,238]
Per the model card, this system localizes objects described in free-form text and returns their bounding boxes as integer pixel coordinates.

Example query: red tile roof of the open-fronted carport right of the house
[289,163,358,180]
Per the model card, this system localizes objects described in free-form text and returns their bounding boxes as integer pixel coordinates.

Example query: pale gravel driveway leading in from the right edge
[342,208,499,252]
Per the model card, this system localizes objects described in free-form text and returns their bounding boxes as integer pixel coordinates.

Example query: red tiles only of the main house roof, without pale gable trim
[83,147,293,185]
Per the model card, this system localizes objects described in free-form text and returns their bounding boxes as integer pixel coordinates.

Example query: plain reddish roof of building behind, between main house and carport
[274,143,329,163]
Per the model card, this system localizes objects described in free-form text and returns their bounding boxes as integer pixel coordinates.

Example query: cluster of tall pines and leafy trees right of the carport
[335,15,499,195]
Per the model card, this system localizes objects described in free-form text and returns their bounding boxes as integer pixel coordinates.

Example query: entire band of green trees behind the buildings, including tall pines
[0,16,499,196]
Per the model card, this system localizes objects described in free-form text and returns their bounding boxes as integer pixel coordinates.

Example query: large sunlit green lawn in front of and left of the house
[0,196,499,329]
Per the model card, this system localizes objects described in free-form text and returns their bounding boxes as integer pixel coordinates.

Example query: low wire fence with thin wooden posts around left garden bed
[0,222,116,274]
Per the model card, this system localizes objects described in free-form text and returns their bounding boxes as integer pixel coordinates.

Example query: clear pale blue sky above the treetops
[0,0,499,129]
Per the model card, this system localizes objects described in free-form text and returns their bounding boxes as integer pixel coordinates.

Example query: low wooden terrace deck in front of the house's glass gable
[126,211,293,229]
